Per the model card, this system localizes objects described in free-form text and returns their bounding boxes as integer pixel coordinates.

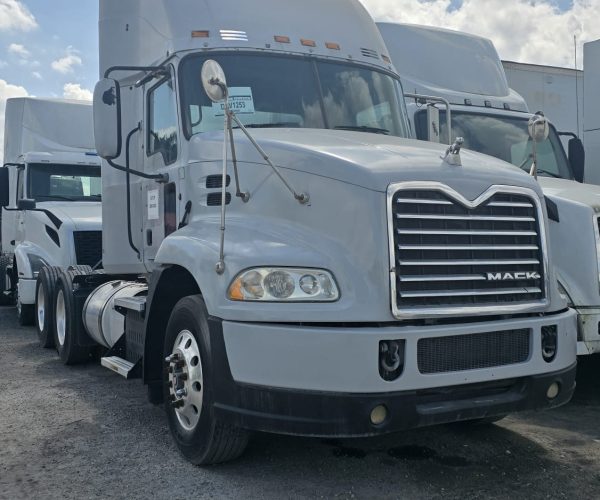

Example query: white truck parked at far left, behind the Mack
[0,97,102,334]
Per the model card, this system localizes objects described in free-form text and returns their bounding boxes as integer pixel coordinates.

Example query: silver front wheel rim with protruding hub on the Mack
[169,330,204,431]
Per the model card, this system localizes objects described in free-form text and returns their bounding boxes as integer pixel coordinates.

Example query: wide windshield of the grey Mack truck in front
[180,54,409,138]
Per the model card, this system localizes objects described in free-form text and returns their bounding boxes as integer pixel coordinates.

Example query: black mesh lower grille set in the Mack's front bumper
[417,329,531,374]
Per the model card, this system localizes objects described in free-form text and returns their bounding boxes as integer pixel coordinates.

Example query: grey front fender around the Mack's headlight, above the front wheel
[155,216,393,322]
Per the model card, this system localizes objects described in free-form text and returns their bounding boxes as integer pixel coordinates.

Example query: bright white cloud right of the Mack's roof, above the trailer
[361,0,600,67]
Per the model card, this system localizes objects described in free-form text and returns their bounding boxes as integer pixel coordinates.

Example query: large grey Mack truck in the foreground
[44,0,576,464]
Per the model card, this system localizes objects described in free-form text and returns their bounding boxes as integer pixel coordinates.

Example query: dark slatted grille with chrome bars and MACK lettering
[390,184,546,315]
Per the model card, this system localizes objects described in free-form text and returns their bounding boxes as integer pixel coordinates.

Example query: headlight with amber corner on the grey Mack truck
[227,267,340,302]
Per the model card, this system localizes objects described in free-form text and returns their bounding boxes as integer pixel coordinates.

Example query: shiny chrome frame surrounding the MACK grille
[387,181,552,319]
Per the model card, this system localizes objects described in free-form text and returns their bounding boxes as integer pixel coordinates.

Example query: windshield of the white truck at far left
[27,163,102,202]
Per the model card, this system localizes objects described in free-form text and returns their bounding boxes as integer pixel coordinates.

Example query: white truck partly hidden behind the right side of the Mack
[378,23,600,354]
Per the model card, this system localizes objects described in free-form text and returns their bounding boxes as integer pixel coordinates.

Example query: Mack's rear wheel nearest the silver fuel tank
[53,267,91,365]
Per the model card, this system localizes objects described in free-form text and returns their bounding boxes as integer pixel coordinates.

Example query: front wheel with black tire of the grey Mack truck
[163,295,248,465]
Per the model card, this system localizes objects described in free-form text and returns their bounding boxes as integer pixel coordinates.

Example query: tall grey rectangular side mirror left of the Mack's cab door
[94,78,122,160]
